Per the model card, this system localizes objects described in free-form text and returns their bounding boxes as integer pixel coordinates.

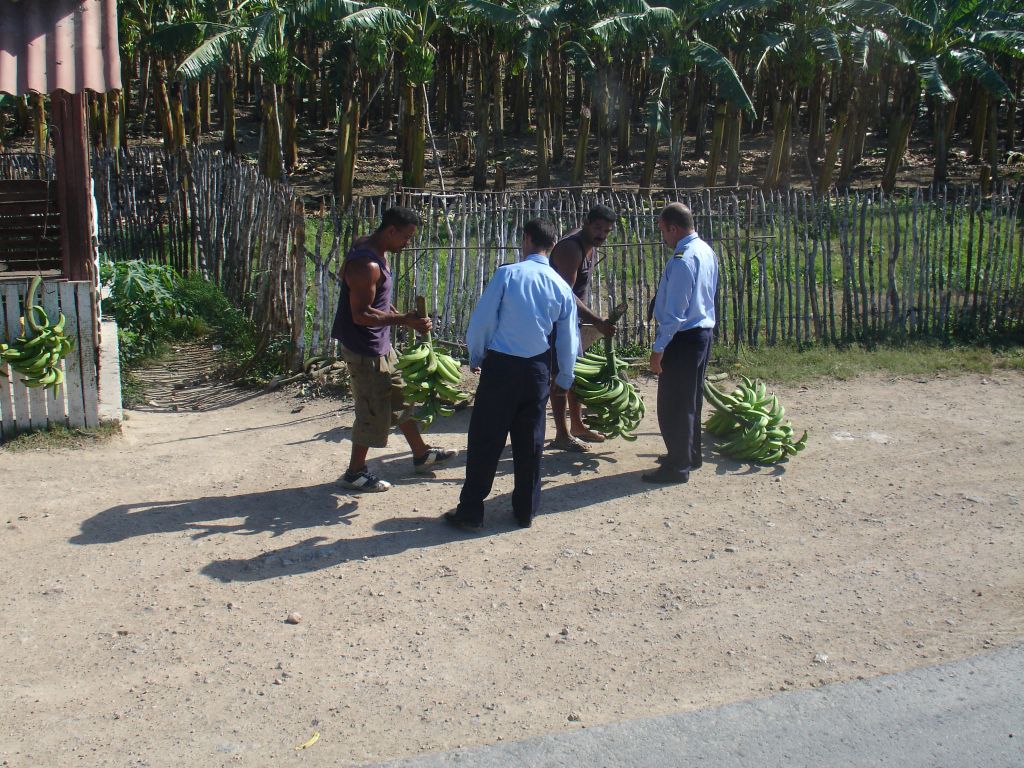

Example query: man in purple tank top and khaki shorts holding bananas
[331,206,455,492]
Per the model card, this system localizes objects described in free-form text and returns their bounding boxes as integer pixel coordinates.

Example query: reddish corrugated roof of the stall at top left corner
[0,0,121,95]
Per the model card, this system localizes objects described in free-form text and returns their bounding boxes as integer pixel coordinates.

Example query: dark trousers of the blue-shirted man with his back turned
[458,351,551,523]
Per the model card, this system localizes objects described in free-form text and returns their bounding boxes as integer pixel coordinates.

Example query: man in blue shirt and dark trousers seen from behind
[444,219,580,530]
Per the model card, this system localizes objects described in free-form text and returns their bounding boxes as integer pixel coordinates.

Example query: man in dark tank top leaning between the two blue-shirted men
[551,205,618,453]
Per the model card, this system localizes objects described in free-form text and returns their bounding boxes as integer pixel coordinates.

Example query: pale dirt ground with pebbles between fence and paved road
[0,373,1024,768]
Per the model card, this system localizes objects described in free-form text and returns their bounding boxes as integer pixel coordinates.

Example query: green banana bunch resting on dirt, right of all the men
[703,376,807,464]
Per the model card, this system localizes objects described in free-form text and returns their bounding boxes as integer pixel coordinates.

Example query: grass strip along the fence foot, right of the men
[710,342,1024,385]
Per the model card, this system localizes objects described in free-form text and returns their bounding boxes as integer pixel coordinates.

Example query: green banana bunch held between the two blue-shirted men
[572,339,646,442]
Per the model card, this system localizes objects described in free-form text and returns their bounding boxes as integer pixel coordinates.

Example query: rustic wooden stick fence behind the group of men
[9,151,1024,372]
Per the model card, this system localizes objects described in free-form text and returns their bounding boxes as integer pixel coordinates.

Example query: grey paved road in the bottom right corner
[372,645,1024,768]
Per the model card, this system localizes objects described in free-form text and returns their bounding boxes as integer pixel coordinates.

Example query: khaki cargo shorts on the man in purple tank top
[341,347,414,447]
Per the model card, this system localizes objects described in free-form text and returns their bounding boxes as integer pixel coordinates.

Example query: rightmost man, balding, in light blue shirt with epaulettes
[643,203,718,483]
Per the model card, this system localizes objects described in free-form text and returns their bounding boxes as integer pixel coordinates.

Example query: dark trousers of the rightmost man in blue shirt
[657,328,713,472]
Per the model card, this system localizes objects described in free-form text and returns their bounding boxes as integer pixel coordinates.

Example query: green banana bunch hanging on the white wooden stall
[0,275,75,397]
